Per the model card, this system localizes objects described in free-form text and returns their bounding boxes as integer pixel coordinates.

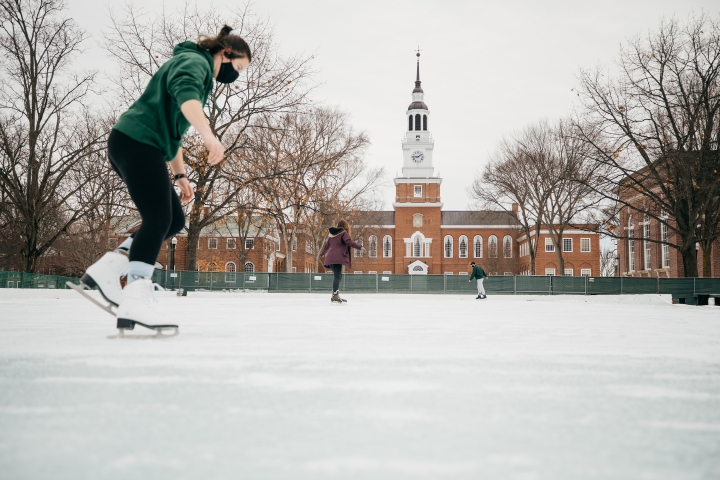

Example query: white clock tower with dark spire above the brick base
[402,52,434,178]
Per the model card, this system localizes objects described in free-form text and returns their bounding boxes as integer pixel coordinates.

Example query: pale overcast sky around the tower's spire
[67,0,720,210]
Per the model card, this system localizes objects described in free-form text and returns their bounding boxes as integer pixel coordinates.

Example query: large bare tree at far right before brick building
[577,14,720,277]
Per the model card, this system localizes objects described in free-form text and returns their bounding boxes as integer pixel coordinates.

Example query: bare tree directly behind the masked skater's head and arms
[105,2,312,269]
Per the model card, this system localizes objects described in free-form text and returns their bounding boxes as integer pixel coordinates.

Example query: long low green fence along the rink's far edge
[0,270,720,304]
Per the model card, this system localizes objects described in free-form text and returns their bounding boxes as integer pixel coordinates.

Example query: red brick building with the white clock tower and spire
[352,55,600,275]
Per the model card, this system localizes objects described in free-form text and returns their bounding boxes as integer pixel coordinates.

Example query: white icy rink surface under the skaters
[0,290,720,480]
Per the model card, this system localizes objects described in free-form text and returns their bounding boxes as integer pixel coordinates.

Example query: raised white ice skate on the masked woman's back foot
[68,252,128,315]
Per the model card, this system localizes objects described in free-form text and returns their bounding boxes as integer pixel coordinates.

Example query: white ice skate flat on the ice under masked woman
[113,278,180,338]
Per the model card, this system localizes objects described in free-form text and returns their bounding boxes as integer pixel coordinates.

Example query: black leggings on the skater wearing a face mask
[108,129,185,265]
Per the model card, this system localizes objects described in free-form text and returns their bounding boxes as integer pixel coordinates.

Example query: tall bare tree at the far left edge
[0,0,107,272]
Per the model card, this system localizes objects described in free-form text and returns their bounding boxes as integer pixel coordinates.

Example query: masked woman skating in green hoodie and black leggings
[82,25,252,323]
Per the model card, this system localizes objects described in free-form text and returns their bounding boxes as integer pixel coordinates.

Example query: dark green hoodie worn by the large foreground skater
[113,42,215,162]
